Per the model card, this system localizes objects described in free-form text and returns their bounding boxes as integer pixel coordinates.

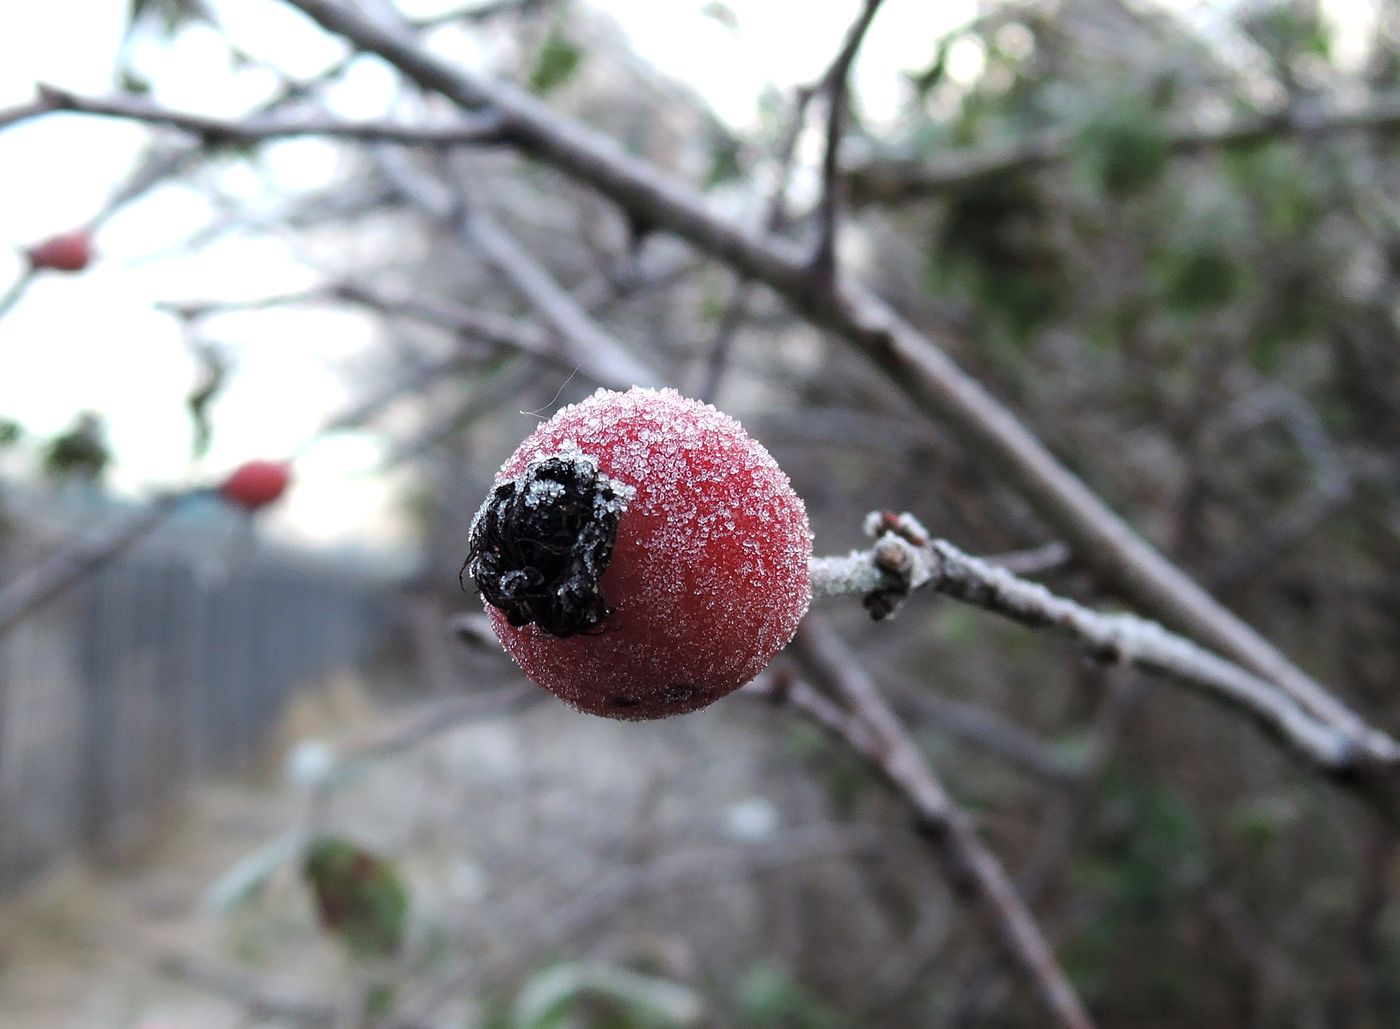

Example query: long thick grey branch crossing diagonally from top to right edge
[273,0,1373,756]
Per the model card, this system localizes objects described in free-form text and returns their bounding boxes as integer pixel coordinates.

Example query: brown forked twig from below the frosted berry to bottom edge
[746,617,1092,1028]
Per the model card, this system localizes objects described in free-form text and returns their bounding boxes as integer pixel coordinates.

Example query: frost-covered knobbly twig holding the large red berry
[812,512,1400,806]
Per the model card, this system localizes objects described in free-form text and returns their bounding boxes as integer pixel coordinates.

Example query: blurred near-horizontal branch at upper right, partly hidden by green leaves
[846,95,1400,203]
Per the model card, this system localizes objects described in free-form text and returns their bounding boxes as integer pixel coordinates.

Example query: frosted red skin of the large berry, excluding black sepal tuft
[486,388,812,721]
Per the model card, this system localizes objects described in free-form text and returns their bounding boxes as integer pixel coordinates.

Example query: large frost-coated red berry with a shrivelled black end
[463,389,812,720]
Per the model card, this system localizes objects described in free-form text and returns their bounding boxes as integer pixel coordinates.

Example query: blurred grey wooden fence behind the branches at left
[0,495,389,892]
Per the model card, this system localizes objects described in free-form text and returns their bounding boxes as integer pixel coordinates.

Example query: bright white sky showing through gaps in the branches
[0,0,1371,543]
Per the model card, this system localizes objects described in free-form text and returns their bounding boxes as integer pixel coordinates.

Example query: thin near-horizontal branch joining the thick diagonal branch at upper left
[23,85,501,147]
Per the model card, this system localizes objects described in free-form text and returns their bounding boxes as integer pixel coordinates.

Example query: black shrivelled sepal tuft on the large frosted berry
[462,451,631,637]
